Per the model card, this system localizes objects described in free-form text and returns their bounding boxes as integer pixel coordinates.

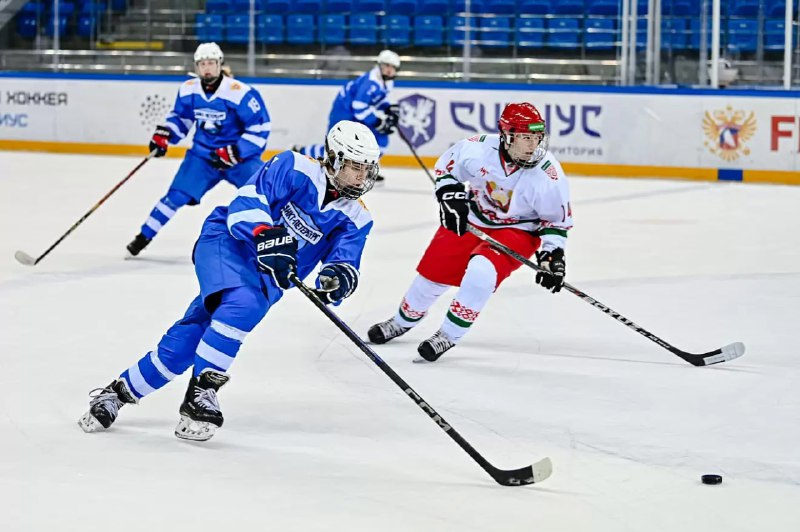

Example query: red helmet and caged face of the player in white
[497,102,550,168]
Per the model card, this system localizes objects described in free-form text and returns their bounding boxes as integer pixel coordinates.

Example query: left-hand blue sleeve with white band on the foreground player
[227,152,295,242]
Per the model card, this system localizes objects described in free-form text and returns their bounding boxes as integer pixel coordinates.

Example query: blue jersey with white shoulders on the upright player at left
[166,76,271,160]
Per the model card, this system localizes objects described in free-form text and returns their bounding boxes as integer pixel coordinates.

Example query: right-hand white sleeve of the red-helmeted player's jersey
[533,159,572,251]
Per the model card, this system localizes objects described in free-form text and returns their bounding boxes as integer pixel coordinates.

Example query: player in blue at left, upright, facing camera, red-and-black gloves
[128,42,271,256]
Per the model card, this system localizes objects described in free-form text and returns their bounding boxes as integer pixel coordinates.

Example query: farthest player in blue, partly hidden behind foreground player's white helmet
[292,50,400,181]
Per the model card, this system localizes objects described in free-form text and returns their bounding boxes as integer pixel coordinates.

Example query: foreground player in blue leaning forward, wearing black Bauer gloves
[78,121,380,441]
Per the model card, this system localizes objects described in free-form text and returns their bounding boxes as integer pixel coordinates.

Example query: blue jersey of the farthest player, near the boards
[329,66,394,129]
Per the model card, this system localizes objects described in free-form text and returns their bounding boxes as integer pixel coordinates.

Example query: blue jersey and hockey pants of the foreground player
[194,151,372,305]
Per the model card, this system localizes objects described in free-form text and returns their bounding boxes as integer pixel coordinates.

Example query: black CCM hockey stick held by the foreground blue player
[290,274,553,486]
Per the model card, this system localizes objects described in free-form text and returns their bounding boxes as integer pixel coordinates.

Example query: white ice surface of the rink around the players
[0,153,800,532]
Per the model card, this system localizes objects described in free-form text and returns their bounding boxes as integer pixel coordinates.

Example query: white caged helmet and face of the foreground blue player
[324,120,381,199]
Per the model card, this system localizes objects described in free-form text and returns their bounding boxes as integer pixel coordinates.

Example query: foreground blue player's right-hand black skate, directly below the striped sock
[175,369,230,441]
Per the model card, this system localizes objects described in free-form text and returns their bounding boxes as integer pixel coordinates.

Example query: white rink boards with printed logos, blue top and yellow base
[0,73,800,184]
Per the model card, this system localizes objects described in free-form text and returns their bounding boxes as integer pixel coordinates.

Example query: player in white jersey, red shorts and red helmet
[368,103,572,362]
